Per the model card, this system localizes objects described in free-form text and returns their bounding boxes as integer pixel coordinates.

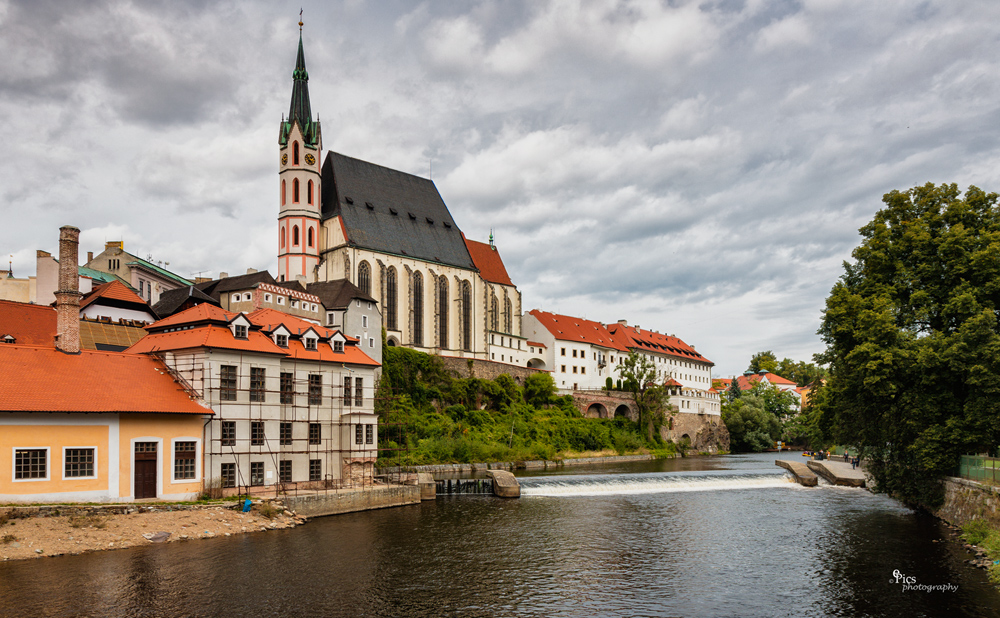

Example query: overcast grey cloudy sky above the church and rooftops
[0,0,1000,376]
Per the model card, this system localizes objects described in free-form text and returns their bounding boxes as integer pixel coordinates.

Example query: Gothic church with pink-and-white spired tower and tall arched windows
[278,31,528,366]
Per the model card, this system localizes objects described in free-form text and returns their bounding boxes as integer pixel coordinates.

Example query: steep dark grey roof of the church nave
[323,152,476,270]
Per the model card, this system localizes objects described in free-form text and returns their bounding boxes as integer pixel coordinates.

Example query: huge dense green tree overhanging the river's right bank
[819,184,1000,506]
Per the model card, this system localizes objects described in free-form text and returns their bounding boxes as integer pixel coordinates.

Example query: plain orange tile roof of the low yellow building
[0,345,212,414]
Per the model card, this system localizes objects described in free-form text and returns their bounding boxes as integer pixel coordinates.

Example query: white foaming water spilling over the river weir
[519,473,798,497]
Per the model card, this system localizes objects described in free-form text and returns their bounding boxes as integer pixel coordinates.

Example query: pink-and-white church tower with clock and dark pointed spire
[278,21,323,282]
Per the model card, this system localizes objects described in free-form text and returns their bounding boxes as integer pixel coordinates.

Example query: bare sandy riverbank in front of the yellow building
[0,502,306,561]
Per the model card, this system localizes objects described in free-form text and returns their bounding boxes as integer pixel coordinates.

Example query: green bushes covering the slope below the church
[376,347,679,468]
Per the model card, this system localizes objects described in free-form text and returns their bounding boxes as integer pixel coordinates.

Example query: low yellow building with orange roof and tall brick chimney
[0,227,212,503]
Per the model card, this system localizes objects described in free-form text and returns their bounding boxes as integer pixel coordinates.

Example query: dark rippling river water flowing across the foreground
[0,454,1000,617]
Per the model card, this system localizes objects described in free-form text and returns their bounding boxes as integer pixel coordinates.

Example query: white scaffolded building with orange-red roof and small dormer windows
[129,303,379,490]
